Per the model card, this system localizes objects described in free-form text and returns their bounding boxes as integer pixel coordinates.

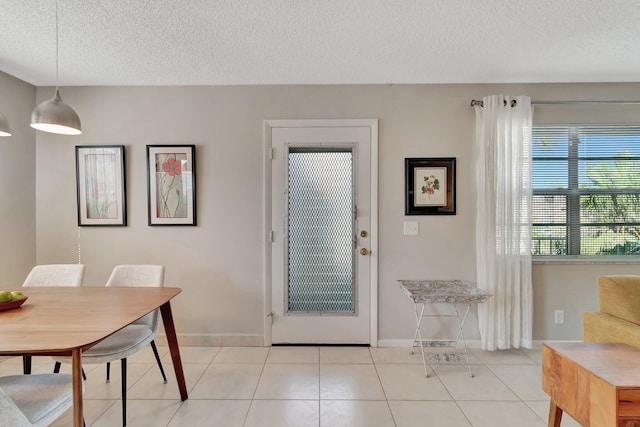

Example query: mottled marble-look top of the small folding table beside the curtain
[398,280,492,304]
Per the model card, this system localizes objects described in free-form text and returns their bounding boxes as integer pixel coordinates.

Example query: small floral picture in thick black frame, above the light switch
[404,157,456,215]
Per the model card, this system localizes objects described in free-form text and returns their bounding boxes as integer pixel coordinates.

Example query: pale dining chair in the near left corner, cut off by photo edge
[0,374,73,427]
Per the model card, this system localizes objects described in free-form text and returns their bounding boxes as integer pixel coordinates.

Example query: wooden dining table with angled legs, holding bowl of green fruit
[0,286,188,427]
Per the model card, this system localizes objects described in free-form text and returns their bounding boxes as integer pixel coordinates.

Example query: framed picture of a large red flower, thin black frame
[147,145,196,225]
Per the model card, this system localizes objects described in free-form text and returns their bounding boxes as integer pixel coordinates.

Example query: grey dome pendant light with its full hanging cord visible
[31,0,82,135]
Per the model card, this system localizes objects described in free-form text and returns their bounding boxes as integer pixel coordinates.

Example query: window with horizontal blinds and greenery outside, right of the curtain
[532,125,640,256]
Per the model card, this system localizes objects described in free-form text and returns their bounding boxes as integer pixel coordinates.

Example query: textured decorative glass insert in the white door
[286,147,356,314]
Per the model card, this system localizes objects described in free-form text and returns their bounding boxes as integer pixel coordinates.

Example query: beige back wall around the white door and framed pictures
[8,84,640,344]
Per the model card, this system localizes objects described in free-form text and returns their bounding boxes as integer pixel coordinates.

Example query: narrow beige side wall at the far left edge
[0,72,36,288]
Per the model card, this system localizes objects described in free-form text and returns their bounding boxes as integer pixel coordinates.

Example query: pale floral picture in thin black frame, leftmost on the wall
[76,145,127,226]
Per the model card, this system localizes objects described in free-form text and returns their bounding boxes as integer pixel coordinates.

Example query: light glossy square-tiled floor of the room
[0,347,578,427]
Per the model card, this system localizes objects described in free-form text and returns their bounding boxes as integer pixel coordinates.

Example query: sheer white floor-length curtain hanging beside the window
[475,95,533,350]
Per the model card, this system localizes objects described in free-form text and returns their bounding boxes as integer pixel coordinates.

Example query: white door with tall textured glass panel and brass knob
[267,121,377,344]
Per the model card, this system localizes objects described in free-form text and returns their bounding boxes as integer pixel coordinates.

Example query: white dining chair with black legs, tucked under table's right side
[56,265,167,426]
